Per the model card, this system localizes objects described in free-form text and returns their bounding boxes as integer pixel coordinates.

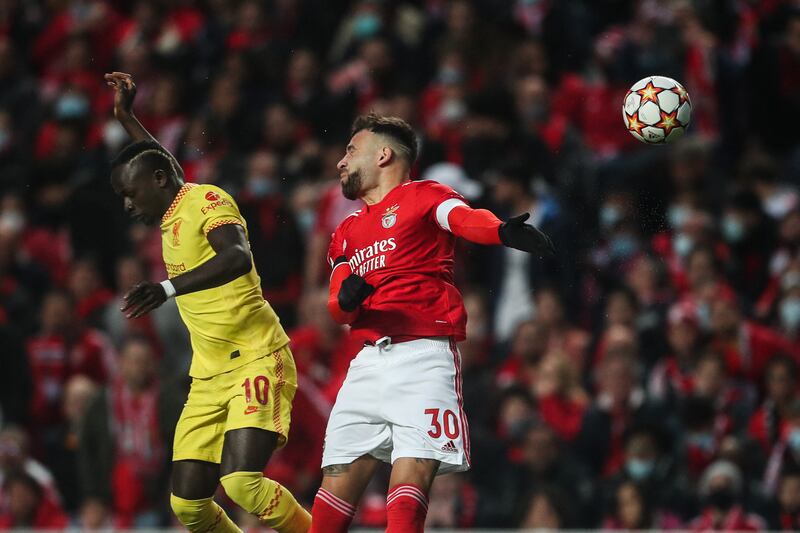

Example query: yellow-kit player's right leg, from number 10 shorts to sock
[220,347,311,533]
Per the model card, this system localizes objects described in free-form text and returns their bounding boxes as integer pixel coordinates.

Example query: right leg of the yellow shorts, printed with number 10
[220,347,297,446]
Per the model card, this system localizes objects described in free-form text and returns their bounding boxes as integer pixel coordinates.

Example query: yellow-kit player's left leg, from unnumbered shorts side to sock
[170,380,241,533]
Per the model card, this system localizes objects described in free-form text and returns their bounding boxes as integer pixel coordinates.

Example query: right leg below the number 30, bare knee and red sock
[386,457,440,533]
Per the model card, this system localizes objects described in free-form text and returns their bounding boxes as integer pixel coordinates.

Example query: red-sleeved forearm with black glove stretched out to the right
[444,204,555,254]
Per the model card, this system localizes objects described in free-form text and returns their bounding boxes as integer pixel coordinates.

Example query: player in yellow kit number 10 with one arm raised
[106,72,311,533]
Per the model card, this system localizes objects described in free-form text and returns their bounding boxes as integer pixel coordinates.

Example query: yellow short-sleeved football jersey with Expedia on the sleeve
[161,183,289,378]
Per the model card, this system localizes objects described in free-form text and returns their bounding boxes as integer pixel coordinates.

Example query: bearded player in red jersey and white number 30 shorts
[311,115,553,533]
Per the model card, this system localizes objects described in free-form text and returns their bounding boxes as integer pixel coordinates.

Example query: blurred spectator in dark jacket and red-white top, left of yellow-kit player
[78,337,180,528]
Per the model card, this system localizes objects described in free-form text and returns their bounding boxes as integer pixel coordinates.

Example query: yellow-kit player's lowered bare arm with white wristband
[122,224,248,318]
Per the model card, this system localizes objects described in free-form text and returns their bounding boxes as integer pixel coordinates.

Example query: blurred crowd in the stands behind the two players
[0,0,800,530]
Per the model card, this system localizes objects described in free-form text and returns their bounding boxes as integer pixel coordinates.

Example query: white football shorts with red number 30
[322,337,469,474]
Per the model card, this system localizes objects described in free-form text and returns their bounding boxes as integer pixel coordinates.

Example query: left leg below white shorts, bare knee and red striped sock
[311,455,380,533]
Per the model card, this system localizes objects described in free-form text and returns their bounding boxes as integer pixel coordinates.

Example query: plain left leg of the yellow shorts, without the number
[172,376,228,465]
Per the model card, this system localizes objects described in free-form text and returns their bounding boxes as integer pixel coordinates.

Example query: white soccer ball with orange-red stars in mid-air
[622,76,692,144]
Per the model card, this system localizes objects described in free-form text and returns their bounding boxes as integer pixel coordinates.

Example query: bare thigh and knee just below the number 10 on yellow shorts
[220,428,279,476]
